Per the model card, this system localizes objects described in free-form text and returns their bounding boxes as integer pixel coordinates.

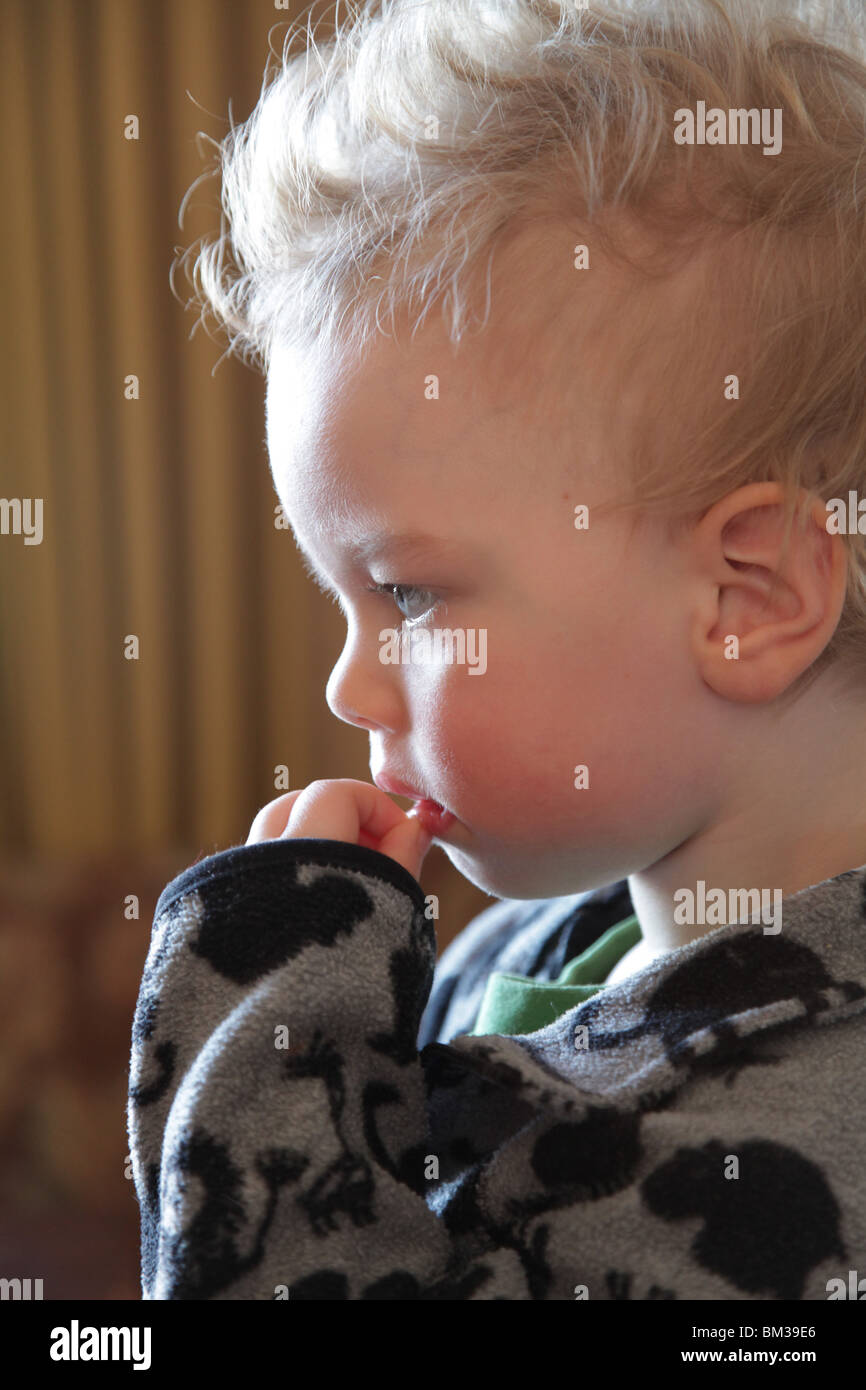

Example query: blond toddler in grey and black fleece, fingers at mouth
[128,0,866,1300]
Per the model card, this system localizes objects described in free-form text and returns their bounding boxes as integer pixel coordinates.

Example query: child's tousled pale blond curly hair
[172,0,866,689]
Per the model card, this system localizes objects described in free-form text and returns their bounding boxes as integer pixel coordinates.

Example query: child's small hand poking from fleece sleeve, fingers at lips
[246,777,432,878]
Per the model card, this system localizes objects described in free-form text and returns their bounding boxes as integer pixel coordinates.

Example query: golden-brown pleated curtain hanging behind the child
[0,0,489,920]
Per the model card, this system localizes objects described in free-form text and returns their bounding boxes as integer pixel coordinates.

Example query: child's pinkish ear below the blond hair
[691,482,848,703]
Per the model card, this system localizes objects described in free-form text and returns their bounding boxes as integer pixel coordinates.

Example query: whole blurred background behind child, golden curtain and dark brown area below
[0,0,492,1300]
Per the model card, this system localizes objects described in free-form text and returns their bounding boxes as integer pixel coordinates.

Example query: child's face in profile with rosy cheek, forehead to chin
[267,239,726,898]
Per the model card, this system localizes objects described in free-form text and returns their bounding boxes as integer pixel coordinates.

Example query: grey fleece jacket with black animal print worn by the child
[128,840,866,1301]
